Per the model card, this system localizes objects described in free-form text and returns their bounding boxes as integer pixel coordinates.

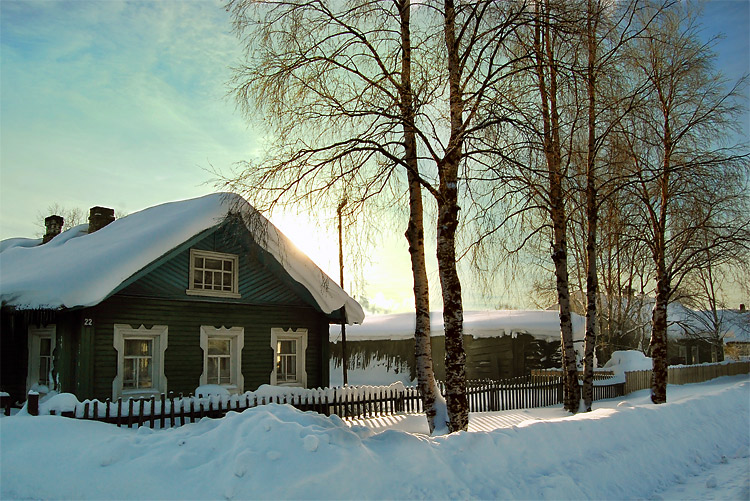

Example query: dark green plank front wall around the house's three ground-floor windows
[78,296,328,399]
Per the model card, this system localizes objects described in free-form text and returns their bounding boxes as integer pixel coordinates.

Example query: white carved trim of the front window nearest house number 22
[112,324,169,400]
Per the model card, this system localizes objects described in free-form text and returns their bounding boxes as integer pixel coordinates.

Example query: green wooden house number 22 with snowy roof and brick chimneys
[0,194,364,401]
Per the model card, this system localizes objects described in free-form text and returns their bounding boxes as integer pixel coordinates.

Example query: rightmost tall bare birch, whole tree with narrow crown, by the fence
[624,3,750,404]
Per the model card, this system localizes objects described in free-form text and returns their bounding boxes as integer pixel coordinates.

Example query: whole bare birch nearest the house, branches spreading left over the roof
[223,0,446,432]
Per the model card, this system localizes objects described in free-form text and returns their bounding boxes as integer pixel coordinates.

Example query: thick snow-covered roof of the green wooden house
[0,193,364,323]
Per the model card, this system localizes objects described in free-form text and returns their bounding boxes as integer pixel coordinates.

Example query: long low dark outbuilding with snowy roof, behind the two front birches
[330,310,585,384]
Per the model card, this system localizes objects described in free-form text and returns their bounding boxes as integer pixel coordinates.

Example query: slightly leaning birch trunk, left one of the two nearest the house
[399,0,445,434]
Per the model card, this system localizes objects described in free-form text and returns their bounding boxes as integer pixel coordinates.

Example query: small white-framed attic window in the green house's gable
[185,249,240,298]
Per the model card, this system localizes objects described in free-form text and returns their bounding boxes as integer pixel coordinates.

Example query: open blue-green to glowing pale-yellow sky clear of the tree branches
[0,0,750,312]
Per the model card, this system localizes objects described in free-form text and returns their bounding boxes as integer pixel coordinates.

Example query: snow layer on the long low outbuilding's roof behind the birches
[330,310,586,342]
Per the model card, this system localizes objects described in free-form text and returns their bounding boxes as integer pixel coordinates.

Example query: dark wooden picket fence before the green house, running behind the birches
[19,375,624,428]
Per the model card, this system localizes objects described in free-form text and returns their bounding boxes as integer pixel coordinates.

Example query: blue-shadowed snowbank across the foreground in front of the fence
[0,376,750,499]
